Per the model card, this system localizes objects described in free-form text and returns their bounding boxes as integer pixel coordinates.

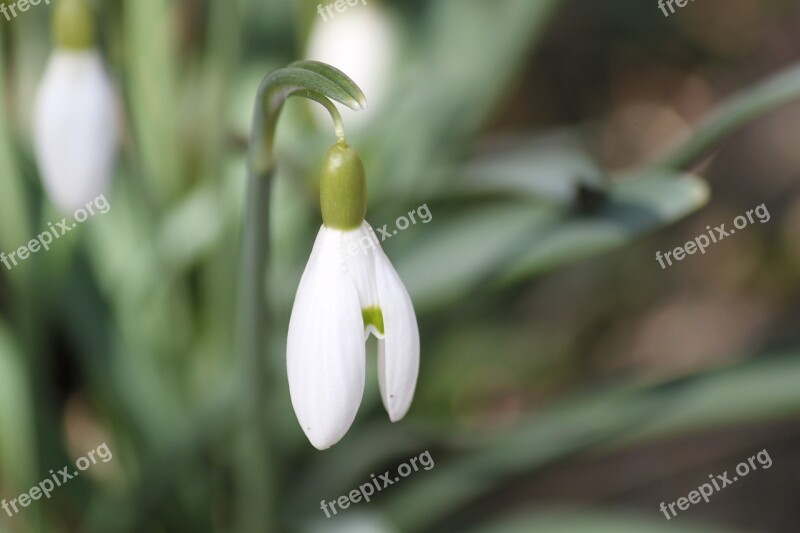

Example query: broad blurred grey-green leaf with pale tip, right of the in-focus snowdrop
[396,167,708,306]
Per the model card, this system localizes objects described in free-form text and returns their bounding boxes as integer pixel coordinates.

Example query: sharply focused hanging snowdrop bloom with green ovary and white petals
[286,143,419,450]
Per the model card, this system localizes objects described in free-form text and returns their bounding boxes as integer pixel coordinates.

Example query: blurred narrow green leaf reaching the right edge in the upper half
[654,65,800,170]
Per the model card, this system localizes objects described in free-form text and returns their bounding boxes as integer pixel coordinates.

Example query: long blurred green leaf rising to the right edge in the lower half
[386,351,800,531]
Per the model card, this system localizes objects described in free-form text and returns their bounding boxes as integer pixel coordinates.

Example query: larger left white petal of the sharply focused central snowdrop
[286,227,365,450]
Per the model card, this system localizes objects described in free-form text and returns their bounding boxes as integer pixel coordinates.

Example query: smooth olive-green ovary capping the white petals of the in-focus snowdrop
[319,142,367,230]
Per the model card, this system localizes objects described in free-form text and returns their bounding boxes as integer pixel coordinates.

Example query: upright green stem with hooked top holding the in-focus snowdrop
[238,61,366,531]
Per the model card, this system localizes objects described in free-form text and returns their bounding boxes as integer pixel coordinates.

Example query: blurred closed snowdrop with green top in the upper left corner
[34,0,119,213]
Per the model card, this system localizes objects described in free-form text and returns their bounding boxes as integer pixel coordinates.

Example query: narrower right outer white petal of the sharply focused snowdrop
[375,247,419,422]
